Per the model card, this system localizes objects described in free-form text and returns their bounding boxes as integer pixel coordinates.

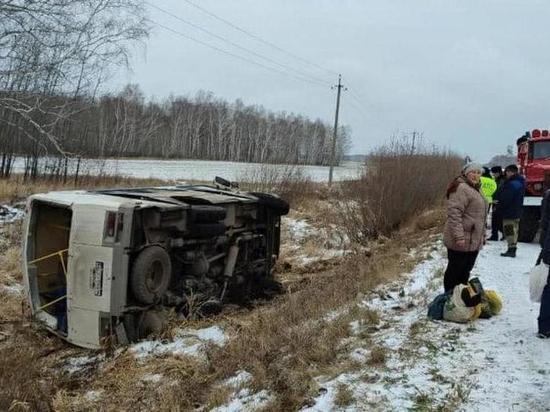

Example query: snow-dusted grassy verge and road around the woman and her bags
[306,242,550,411]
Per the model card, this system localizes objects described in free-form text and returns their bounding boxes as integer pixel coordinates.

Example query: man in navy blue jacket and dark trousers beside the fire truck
[493,165,525,257]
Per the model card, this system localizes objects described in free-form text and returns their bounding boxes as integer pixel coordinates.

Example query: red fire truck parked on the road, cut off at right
[517,129,550,242]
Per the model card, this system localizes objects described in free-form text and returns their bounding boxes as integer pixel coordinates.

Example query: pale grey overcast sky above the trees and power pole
[111,0,550,161]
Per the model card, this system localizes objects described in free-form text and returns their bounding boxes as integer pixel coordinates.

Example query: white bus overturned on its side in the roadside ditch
[23,179,288,348]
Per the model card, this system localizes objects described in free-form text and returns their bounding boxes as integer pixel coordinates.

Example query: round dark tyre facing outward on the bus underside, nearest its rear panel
[130,246,172,305]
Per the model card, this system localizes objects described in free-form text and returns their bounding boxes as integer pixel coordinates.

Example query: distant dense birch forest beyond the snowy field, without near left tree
[0,85,349,165]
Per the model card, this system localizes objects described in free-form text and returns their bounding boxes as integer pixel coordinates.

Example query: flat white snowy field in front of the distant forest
[10,158,362,182]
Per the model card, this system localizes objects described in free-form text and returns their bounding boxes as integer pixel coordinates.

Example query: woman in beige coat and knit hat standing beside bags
[443,163,487,292]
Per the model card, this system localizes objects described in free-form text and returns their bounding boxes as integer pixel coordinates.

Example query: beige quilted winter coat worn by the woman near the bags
[443,177,487,252]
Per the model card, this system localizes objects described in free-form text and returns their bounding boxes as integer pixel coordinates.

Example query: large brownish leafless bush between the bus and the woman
[339,137,461,244]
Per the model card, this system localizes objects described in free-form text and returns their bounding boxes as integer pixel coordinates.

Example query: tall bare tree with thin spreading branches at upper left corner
[0,0,148,175]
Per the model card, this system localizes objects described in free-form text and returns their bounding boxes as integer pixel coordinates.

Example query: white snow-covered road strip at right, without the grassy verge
[463,242,550,411]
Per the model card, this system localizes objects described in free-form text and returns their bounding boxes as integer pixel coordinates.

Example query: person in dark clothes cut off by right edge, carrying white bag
[538,190,550,339]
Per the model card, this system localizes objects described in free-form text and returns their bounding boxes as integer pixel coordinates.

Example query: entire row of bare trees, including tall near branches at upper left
[0,0,349,177]
